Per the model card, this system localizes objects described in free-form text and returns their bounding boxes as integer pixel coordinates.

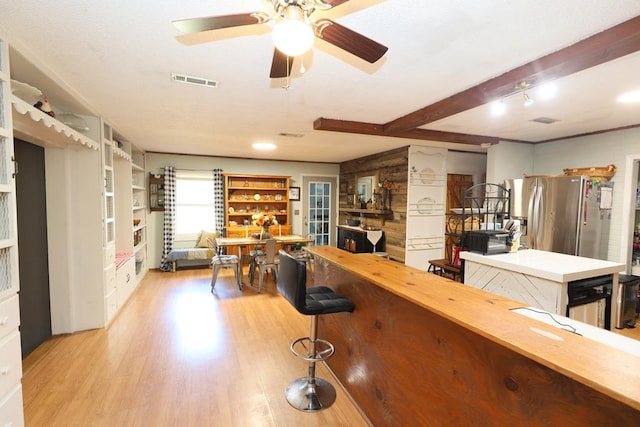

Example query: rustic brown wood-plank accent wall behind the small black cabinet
[338,147,409,262]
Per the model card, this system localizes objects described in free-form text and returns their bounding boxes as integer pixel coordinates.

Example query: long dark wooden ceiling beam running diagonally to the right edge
[376,16,640,134]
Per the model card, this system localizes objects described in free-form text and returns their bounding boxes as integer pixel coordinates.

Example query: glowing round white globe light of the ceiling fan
[272,6,315,56]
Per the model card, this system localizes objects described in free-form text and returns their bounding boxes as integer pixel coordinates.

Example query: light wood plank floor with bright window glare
[22,269,368,427]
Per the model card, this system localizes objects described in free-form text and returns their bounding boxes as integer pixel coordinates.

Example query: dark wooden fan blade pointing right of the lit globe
[316,19,389,64]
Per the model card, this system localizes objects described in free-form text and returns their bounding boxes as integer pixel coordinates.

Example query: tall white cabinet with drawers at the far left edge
[0,29,24,426]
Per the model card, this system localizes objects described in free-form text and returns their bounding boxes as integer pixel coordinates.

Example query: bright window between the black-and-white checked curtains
[176,171,216,240]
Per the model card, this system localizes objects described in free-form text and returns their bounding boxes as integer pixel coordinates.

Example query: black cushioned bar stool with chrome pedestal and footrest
[277,250,354,412]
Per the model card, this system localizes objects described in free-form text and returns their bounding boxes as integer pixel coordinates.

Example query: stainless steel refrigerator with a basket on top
[505,176,613,260]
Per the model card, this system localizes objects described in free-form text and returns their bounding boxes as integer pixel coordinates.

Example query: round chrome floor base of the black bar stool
[284,377,336,412]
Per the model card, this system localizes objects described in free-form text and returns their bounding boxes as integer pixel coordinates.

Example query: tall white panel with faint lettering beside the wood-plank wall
[405,145,447,271]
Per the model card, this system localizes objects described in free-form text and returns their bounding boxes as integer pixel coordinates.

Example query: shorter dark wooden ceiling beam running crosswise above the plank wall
[313,117,498,145]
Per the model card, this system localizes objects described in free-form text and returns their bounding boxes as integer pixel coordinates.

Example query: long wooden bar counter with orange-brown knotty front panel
[308,246,640,426]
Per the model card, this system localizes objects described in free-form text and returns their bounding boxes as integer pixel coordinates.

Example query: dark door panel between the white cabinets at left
[15,139,51,359]
